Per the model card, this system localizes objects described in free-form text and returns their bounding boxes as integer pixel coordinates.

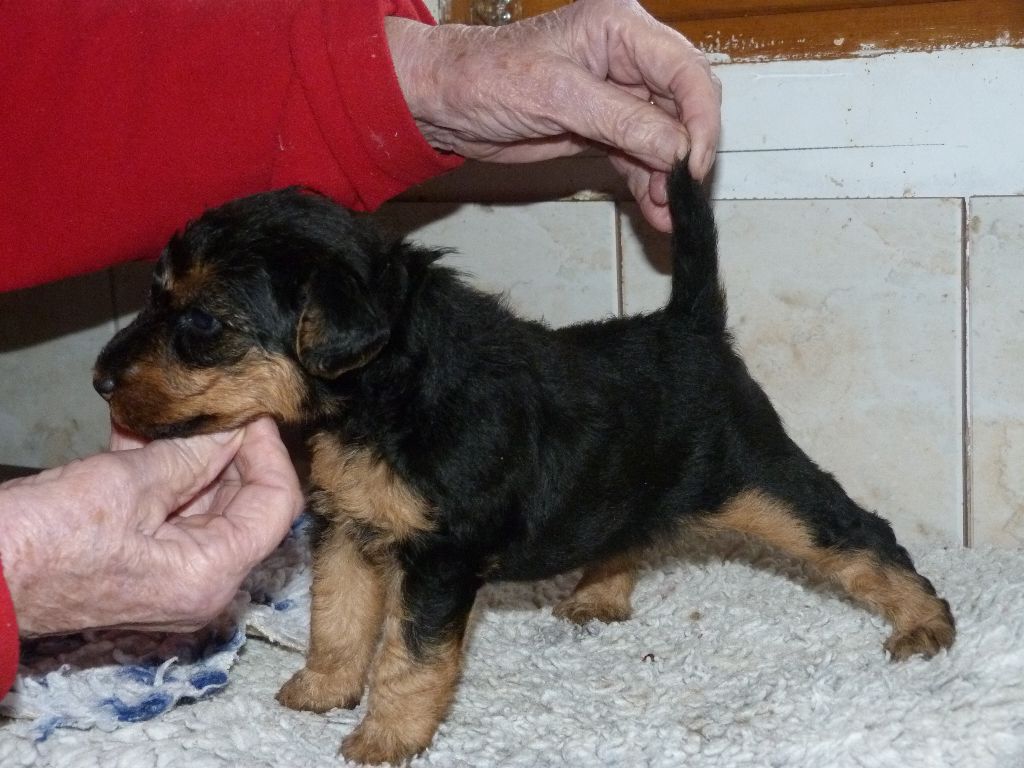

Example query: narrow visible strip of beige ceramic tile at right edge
[969,198,1024,547]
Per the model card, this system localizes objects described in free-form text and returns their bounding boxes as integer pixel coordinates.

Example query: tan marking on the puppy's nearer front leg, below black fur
[341,567,462,764]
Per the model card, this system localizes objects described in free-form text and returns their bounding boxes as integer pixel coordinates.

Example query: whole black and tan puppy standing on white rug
[95,169,954,763]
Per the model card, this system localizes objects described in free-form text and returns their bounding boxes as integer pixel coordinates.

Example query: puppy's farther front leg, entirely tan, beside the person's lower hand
[278,523,384,712]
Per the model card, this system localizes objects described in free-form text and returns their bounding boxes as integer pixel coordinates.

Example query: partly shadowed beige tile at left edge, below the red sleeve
[0,272,114,467]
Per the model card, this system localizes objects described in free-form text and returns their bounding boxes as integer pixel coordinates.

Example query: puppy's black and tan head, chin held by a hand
[93,189,408,437]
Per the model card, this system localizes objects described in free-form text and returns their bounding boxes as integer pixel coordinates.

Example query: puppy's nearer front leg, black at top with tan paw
[341,559,478,764]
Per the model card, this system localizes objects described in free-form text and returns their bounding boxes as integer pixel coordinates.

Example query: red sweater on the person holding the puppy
[0,0,460,696]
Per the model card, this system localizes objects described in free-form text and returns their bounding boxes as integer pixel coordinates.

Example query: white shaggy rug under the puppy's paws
[0,541,1024,768]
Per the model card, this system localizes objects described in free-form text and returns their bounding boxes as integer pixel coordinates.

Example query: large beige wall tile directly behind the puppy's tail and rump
[623,200,964,551]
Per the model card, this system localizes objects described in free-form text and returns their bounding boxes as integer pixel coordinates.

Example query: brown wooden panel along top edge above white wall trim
[449,0,1024,61]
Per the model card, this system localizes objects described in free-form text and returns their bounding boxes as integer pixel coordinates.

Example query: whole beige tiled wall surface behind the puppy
[0,198,1024,549]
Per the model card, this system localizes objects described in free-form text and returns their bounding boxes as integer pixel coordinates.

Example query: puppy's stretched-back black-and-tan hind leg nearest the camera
[706,479,955,659]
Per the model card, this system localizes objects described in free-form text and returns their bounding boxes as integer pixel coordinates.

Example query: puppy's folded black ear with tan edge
[295,271,390,379]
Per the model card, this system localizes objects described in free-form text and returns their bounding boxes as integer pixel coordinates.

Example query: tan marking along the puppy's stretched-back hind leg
[705,492,955,659]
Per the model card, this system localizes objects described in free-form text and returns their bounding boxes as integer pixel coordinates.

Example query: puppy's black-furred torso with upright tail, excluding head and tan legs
[325,171,770,579]
